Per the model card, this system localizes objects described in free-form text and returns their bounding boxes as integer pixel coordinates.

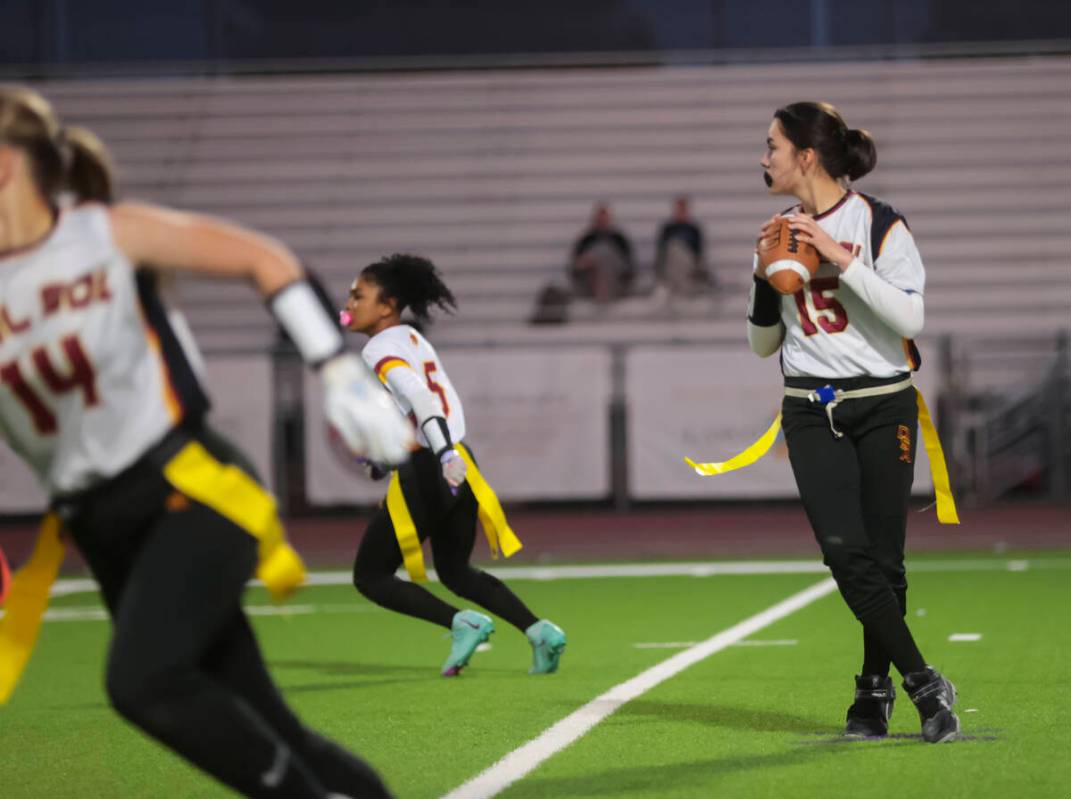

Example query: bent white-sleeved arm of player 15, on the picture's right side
[838,221,925,338]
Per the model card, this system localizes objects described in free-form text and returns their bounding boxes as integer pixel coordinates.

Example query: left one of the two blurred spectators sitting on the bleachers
[569,202,636,302]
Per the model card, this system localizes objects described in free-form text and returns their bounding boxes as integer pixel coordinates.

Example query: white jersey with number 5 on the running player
[361,325,465,448]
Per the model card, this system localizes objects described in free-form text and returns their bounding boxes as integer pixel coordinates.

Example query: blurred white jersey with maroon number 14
[0,205,208,496]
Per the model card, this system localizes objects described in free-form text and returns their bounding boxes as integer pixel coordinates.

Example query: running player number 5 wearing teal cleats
[343,255,565,676]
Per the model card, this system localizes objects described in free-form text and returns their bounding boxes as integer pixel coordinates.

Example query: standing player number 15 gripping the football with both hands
[748,103,959,742]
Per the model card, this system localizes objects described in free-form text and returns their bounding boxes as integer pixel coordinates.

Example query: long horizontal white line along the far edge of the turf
[39,558,1071,597]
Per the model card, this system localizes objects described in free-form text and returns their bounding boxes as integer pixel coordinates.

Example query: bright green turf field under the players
[0,554,1071,799]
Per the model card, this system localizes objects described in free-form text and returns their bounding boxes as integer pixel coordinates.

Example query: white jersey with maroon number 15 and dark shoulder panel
[766,191,925,377]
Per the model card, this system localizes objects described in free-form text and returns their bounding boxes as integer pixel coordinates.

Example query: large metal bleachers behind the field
[41,57,1071,350]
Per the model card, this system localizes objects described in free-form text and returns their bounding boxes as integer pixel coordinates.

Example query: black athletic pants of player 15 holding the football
[782,375,925,674]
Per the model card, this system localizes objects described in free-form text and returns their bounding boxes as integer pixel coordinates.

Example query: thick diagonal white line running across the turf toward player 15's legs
[443,578,836,799]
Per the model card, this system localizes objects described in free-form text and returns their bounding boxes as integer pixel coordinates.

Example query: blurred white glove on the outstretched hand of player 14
[320,352,416,466]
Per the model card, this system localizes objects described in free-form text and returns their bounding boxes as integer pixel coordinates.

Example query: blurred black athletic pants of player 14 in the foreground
[57,431,390,799]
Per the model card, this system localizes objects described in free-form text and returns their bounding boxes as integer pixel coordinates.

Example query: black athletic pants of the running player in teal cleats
[353,450,539,631]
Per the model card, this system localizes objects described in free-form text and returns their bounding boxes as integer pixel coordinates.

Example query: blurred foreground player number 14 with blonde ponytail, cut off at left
[0,88,412,799]
